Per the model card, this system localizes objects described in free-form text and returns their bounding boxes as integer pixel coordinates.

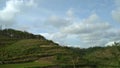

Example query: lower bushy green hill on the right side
[62,42,120,68]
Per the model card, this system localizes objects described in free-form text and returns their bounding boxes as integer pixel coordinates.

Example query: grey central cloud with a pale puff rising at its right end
[45,8,75,29]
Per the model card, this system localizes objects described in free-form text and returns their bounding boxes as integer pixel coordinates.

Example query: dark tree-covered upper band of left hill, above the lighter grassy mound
[0,29,58,45]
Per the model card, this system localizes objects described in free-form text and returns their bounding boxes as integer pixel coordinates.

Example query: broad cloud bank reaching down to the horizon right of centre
[43,13,120,48]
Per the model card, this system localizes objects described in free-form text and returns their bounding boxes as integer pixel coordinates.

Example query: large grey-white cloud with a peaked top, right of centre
[62,14,110,34]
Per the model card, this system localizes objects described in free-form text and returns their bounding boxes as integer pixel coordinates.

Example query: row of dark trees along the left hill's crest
[0,29,45,40]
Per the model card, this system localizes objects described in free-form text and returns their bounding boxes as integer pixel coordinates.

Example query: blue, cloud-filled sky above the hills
[0,0,120,48]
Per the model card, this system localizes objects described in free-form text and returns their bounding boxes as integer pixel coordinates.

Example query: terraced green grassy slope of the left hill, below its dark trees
[0,39,75,68]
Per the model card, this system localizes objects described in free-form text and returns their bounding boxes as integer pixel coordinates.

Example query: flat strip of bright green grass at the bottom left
[0,62,53,68]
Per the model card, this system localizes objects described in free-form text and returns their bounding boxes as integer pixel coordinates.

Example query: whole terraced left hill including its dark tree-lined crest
[0,29,90,67]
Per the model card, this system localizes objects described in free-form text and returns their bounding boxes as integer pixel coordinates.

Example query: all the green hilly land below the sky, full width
[0,29,120,68]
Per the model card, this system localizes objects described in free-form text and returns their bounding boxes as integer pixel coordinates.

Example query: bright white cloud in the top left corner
[0,0,35,26]
